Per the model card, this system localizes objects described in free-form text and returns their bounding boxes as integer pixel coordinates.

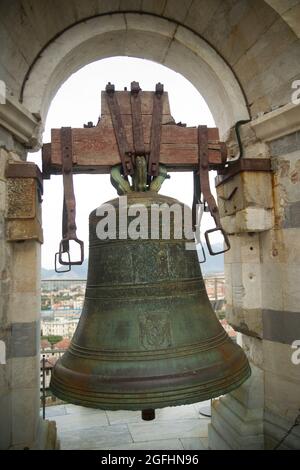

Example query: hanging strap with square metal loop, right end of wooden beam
[198,126,230,255]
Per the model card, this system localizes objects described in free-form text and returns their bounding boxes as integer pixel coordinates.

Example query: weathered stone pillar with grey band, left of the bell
[0,148,56,449]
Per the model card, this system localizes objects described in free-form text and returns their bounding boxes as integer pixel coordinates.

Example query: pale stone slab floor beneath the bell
[46,401,210,450]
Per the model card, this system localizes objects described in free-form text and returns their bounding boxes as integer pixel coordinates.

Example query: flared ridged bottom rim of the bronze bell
[50,357,251,410]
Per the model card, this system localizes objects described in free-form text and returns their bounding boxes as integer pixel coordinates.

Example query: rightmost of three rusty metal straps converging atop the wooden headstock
[148,83,164,176]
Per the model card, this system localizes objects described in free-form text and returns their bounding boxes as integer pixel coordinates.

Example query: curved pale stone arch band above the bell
[23,13,249,135]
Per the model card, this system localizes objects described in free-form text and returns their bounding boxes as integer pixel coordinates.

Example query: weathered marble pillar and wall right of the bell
[210,116,300,449]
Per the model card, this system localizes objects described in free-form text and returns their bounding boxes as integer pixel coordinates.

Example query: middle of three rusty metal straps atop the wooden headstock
[130,82,145,156]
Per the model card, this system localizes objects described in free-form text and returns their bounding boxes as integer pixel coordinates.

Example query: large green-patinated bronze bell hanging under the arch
[51,162,250,410]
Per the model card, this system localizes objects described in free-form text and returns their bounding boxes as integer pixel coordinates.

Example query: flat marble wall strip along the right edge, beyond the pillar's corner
[261,132,300,449]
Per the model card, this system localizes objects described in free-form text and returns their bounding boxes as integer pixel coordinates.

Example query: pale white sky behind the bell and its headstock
[28,57,220,269]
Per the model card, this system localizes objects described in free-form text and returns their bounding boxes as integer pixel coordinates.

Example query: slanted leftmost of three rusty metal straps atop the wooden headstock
[105,83,134,176]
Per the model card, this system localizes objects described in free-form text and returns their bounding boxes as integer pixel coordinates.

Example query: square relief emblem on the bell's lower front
[139,313,172,350]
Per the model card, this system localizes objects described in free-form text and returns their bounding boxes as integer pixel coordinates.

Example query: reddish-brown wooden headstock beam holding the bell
[42,91,226,174]
